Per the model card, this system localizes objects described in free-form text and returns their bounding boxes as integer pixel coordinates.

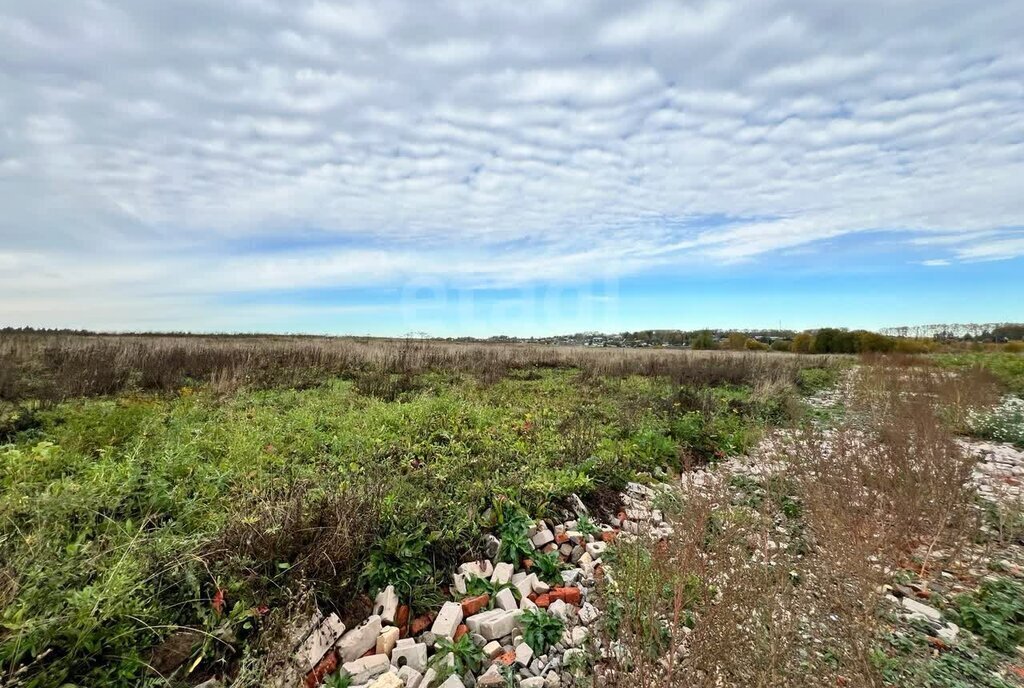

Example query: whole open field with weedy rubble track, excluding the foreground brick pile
[0,336,1024,688]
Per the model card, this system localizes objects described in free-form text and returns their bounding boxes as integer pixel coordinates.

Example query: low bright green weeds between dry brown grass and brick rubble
[0,370,794,687]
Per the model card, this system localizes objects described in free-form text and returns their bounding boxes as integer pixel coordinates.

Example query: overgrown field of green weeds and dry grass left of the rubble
[0,340,831,686]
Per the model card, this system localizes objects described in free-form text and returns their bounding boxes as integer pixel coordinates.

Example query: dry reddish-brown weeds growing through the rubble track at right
[602,359,994,688]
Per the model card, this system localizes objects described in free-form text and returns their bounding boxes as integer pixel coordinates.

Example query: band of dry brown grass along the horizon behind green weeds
[0,333,824,400]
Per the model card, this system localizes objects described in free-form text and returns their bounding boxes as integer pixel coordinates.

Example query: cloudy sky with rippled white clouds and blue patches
[0,0,1024,336]
